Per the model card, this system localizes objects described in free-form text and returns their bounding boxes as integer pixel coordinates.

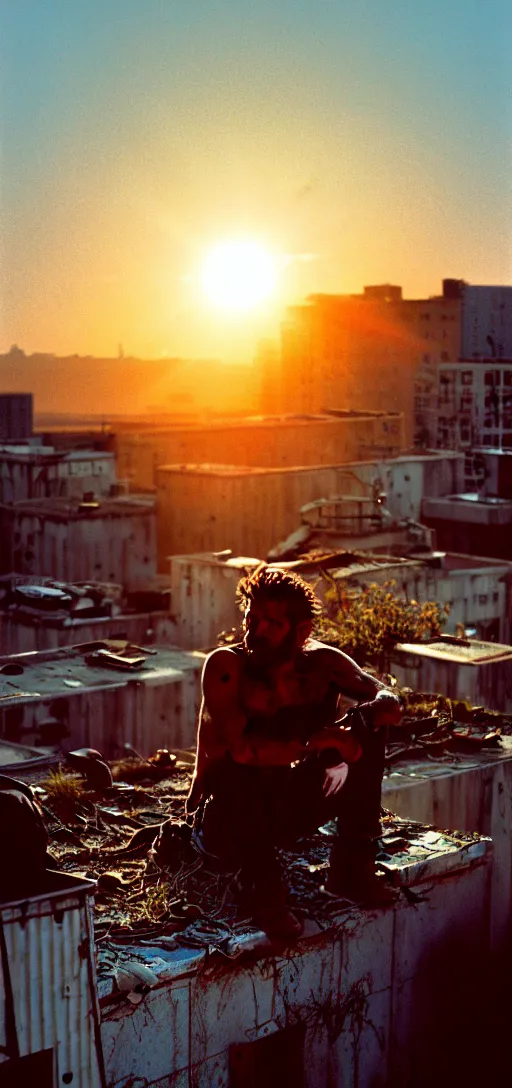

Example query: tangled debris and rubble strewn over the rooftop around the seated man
[3,691,500,1004]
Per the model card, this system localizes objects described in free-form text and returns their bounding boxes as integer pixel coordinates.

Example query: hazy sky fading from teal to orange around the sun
[0,0,512,358]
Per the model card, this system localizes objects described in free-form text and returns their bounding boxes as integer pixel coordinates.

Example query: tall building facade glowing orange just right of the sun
[280,281,461,444]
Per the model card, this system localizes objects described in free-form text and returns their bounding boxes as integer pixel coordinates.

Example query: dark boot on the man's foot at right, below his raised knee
[324,838,398,910]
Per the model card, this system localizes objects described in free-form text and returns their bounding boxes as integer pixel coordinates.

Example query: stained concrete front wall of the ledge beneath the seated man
[102,842,491,1088]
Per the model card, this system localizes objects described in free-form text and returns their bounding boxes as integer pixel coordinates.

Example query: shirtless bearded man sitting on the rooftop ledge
[187,567,401,937]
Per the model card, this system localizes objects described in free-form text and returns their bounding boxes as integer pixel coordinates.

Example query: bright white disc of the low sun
[201,238,277,313]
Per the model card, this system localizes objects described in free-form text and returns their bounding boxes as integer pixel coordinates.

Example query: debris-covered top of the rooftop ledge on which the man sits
[12,751,487,979]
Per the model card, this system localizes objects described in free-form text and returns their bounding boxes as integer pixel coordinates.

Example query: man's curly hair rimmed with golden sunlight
[236,566,322,623]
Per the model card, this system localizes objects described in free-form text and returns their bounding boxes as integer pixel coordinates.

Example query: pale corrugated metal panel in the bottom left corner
[0,875,104,1088]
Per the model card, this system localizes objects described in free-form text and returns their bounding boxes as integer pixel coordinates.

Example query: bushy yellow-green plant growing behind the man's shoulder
[315,579,450,672]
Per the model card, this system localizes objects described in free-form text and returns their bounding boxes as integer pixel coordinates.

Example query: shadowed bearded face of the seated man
[243,597,299,665]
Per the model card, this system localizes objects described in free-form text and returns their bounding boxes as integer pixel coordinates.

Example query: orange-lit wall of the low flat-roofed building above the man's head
[157,453,465,573]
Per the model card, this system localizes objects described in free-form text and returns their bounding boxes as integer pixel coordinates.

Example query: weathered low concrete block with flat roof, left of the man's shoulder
[0,643,204,759]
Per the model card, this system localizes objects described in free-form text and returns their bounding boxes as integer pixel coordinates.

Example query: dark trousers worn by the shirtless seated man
[201,729,385,896]
